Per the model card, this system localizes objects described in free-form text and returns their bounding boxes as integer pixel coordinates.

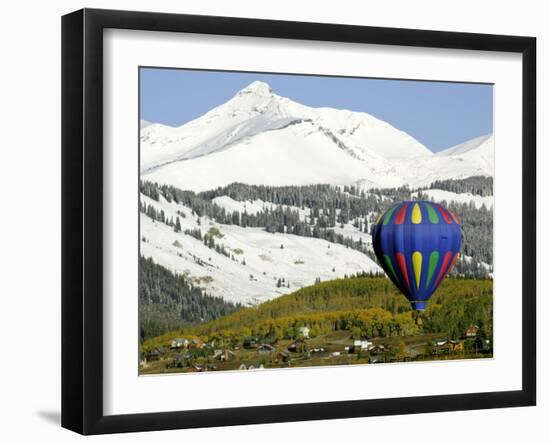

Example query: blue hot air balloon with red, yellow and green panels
[372,201,462,319]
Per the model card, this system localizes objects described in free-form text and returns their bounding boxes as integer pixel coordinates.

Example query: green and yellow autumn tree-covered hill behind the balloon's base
[144,276,493,348]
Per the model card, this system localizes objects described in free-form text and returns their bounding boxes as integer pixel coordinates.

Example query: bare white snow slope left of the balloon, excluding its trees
[140,195,379,304]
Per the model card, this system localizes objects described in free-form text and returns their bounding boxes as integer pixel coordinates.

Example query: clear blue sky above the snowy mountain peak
[140,68,493,152]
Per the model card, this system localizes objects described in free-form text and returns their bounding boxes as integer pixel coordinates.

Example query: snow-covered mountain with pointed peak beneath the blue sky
[140,82,493,191]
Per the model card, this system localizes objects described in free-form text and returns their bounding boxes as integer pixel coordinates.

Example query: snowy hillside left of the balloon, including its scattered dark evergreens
[140,183,379,305]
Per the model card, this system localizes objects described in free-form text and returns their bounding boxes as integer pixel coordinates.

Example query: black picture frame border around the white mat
[62,9,536,434]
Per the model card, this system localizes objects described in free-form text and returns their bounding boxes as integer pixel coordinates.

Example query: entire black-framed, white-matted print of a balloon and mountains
[62,9,536,434]
